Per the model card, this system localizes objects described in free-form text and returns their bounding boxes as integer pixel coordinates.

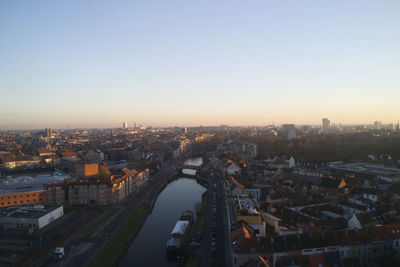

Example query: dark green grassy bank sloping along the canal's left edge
[88,204,150,267]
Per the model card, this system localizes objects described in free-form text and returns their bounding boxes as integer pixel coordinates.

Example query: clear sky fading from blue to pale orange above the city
[0,0,400,130]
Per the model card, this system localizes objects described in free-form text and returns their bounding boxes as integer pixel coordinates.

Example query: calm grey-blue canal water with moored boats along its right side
[119,177,206,267]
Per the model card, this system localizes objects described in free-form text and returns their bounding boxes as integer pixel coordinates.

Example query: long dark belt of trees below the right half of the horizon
[191,133,400,162]
